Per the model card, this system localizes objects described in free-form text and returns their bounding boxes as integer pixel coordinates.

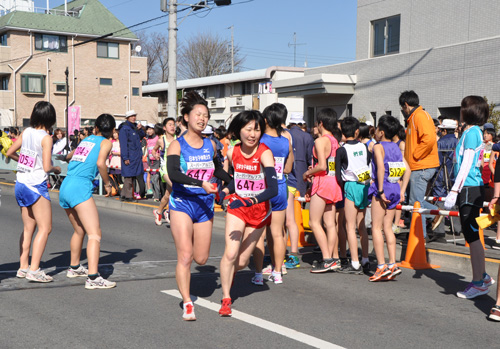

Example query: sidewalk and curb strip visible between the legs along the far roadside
[0,171,500,277]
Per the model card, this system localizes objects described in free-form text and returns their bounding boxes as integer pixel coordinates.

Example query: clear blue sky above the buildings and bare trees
[35,0,357,70]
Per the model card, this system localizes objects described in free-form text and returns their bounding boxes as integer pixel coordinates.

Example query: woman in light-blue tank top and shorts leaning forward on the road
[59,114,116,290]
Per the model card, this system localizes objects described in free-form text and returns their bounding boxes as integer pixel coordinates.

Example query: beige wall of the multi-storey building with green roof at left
[0,32,158,127]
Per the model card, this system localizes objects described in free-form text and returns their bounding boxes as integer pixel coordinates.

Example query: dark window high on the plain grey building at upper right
[372,15,401,57]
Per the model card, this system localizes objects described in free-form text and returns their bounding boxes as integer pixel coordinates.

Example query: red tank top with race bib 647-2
[232,143,269,198]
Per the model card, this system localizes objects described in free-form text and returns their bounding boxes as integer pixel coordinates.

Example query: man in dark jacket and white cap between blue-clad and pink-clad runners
[288,114,314,196]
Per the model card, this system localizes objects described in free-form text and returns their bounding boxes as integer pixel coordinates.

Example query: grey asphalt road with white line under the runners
[0,186,500,348]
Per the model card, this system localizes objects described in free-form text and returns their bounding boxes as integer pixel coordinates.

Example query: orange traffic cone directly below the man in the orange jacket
[399,201,439,269]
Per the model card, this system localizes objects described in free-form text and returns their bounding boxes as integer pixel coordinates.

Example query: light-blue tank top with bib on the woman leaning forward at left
[68,135,105,181]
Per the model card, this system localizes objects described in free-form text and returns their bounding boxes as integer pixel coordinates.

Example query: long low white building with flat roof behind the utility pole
[143,67,304,126]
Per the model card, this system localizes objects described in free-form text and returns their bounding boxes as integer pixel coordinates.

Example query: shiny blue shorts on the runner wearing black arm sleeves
[168,191,214,223]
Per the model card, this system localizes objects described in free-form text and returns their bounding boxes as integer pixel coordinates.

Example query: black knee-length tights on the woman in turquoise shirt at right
[457,186,484,244]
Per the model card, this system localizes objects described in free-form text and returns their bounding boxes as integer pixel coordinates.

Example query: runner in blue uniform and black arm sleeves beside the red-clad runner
[167,92,231,321]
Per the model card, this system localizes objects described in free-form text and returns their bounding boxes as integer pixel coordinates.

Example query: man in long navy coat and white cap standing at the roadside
[119,110,146,201]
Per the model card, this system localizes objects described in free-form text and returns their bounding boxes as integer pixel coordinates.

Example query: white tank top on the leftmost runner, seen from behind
[16,127,52,185]
